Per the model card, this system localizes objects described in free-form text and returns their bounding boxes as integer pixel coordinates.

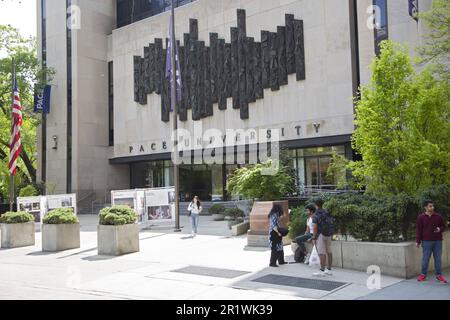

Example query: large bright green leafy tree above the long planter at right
[350,41,450,195]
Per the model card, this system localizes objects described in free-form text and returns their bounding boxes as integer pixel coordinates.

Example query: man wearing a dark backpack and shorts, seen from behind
[312,199,335,277]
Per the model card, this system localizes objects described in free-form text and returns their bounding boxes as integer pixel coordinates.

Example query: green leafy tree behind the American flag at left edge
[0,25,53,198]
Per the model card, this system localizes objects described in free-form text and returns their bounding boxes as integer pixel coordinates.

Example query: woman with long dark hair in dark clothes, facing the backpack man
[269,204,286,267]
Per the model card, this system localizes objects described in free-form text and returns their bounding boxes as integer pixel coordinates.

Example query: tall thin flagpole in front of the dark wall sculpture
[170,0,181,232]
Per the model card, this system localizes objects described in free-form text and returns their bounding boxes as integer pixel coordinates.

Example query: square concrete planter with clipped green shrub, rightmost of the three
[97,206,139,256]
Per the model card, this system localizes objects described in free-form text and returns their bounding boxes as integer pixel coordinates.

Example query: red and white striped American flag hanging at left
[8,81,22,176]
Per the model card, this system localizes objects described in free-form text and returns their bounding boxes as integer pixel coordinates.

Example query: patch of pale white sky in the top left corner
[0,0,36,37]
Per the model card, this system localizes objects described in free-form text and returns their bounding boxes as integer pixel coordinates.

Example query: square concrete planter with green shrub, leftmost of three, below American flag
[0,212,35,248]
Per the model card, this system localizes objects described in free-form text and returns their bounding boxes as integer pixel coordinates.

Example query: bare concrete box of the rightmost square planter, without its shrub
[97,223,139,256]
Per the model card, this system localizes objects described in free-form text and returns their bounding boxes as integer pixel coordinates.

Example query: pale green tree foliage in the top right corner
[419,0,450,81]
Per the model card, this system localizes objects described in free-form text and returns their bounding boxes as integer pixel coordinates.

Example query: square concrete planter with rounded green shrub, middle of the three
[42,208,80,252]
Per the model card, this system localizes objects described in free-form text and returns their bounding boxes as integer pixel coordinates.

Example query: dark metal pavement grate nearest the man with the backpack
[252,274,347,291]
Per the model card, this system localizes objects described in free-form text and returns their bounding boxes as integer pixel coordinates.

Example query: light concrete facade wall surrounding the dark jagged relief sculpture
[111,0,353,157]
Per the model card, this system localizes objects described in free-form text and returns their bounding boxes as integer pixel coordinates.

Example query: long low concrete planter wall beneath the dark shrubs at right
[292,232,450,279]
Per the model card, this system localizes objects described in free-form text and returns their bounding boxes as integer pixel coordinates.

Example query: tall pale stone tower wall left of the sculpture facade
[37,0,129,202]
